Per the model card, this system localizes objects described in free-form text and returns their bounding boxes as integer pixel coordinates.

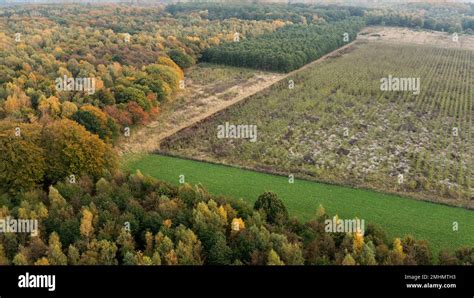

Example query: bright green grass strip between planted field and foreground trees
[123,154,474,253]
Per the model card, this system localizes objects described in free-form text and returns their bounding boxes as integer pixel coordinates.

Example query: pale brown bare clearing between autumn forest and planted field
[118,63,283,153]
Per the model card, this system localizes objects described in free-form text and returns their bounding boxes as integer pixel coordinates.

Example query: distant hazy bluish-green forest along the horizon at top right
[166,2,474,33]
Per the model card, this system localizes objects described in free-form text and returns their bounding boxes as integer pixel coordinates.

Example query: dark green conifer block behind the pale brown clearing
[202,17,365,72]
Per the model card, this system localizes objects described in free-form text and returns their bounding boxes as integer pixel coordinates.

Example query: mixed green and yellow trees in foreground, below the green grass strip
[0,172,474,265]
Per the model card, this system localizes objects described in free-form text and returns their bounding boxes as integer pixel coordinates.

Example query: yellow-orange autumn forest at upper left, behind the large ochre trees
[0,5,283,142]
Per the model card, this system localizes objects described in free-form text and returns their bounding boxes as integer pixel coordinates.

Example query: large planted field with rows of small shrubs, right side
[161,42,474,207]
